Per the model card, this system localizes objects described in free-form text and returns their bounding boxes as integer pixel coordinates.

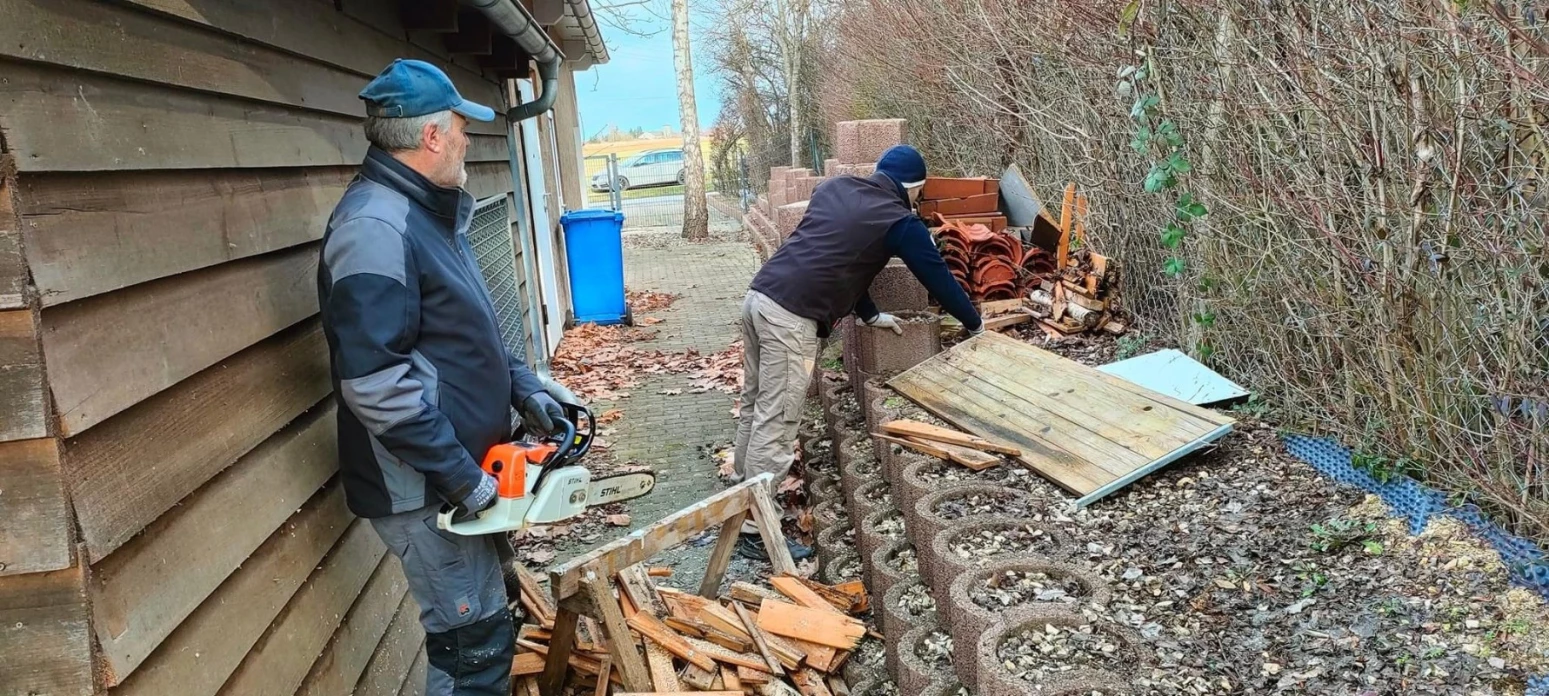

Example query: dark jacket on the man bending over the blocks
[753,172,981,336]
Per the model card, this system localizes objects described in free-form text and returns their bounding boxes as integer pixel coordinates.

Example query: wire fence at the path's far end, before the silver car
[584,149,753,229]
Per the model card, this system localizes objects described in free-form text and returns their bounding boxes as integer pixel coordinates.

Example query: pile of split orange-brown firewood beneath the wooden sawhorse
[511,564,869,696]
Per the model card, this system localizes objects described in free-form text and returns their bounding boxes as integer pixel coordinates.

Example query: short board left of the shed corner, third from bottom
[0,310,48,442]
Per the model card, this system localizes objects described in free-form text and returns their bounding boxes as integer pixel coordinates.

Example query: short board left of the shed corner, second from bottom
[0,437,71,573]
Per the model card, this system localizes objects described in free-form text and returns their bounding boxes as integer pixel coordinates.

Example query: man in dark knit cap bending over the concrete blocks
[736,146,984,558]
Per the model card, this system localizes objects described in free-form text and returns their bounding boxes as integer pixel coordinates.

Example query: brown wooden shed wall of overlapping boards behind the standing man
[0,0,539,696]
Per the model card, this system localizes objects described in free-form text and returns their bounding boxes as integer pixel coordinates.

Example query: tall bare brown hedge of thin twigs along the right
[819,0,1549,539]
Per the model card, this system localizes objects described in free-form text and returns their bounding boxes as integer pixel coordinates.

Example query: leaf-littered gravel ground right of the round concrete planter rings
[985,338,1549,696]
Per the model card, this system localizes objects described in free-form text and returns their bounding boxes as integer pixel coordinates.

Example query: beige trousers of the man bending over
[734,290,818,533]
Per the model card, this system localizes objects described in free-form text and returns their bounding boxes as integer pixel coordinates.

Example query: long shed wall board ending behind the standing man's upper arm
[43,245,318,436]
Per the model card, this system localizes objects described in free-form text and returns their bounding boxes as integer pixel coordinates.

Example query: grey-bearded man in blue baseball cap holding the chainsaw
[318,60,564,696]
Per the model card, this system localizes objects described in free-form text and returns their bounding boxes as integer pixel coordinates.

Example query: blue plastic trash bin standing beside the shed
[559,211,629,324]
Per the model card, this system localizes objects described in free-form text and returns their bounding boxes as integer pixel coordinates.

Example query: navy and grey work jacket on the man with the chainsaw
[318,147,542,518]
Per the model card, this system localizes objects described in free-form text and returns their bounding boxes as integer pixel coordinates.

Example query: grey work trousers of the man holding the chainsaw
[372,504,516,696]
